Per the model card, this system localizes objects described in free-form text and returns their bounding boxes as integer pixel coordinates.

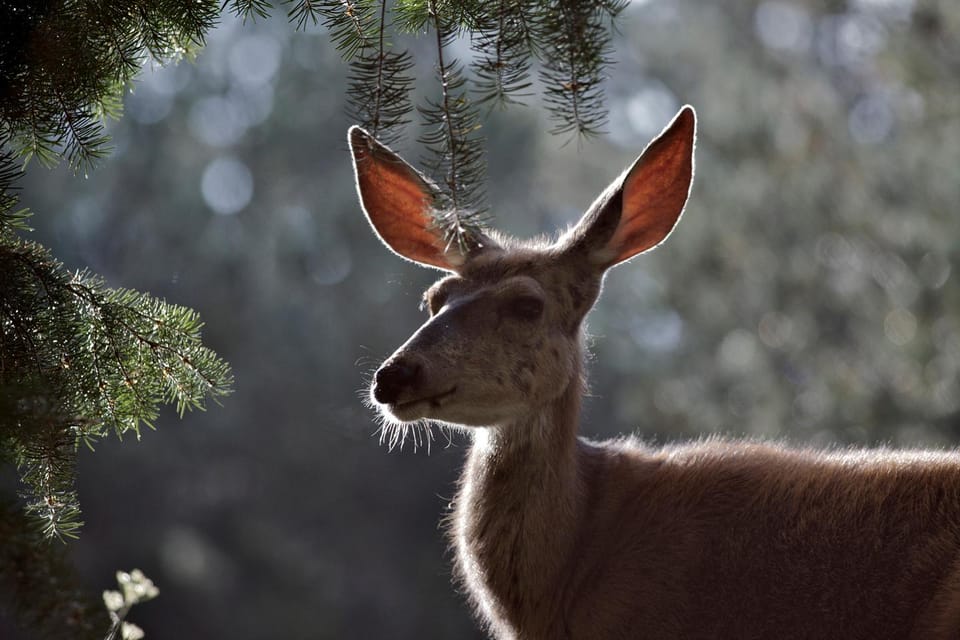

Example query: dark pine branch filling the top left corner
[0,0,219,170]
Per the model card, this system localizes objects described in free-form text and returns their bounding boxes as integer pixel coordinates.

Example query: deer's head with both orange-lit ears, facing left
[349,106,696,436]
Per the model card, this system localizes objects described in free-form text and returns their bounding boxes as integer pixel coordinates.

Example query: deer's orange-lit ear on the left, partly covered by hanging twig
[347,126,463,271]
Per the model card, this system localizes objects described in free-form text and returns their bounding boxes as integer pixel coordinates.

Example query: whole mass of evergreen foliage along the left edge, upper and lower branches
[0,2,231,552]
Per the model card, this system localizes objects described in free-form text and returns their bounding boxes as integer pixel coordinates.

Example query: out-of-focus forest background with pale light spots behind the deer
[11,0,960,640]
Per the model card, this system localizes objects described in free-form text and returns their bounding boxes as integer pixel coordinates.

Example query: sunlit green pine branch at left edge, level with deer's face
[0,235,232,538]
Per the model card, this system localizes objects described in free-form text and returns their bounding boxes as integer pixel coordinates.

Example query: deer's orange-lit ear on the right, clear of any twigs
[562,105,697,269]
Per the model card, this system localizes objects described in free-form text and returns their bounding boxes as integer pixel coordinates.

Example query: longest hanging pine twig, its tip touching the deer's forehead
[419,0,486,251]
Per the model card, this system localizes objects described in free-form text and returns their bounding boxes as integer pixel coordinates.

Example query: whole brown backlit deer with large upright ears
[348,106,960,640]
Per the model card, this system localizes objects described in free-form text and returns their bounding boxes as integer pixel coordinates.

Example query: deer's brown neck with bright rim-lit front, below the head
[453,358,584,630]
